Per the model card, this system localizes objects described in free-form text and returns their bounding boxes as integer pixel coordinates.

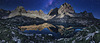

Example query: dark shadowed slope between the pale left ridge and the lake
[5,16,45,25]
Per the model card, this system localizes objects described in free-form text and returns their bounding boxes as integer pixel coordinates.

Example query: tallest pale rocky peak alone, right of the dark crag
[58,3,75,17]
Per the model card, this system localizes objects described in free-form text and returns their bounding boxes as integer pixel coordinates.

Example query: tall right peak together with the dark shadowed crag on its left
[49,3,75,18]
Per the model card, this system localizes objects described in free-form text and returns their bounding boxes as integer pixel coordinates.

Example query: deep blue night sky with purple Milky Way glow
[0,0,100,19]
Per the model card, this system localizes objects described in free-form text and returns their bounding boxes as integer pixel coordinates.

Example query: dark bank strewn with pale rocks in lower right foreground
[58,24,100,43]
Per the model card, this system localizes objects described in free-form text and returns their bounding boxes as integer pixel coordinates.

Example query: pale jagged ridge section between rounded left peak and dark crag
[25,10,53,21]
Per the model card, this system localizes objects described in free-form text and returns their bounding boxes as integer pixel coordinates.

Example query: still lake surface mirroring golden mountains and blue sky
[19,23,84,38]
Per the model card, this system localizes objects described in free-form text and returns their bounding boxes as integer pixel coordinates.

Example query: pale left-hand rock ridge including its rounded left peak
[6,6,53,20]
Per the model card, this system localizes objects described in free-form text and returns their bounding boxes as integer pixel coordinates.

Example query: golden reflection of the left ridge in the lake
[19,23,56,32]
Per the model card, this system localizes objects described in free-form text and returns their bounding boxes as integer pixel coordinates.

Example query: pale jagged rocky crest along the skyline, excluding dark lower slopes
[0,3,94,20]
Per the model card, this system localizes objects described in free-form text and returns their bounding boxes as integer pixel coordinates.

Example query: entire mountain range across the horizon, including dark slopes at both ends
[0,3,100,25]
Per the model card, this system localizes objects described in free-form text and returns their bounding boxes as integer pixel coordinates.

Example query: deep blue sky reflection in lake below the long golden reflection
[24,28,61,39]
